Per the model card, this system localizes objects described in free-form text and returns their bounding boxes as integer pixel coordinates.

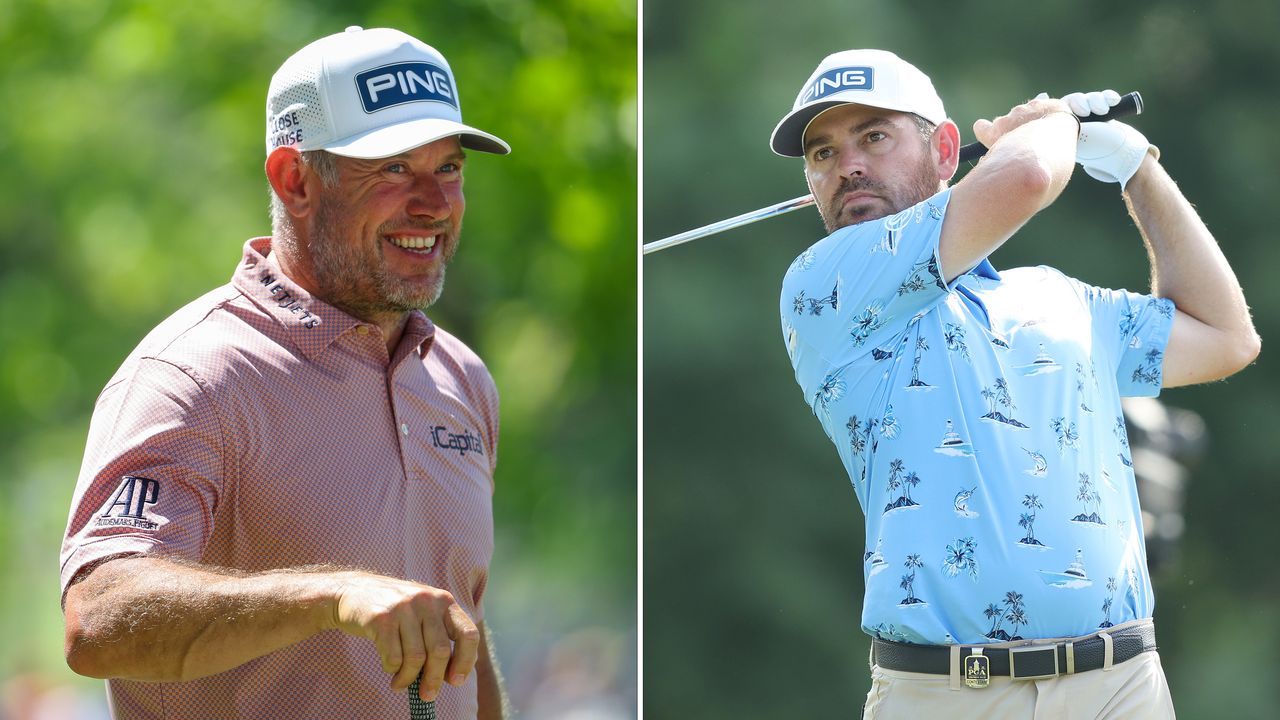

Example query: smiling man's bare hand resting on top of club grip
[333,571,480,701]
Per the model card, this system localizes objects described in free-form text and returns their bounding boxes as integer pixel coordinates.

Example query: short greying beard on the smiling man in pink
[310,194,456,319]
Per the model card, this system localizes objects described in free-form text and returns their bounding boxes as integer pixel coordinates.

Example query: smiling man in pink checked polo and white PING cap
[61,27,509,719]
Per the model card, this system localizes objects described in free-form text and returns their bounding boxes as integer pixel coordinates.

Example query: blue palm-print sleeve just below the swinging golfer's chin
[780,188,951,388]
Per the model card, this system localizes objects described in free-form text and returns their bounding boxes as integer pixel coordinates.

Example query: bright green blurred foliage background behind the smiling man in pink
[0,0,637,719]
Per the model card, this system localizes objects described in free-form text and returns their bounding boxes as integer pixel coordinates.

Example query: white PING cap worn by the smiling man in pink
[266,26,511,159]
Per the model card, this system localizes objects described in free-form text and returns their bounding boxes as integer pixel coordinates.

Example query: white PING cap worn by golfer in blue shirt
[769,50,947,158]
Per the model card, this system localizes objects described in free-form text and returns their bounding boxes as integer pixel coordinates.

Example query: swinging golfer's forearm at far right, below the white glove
[1124,155,1258,354]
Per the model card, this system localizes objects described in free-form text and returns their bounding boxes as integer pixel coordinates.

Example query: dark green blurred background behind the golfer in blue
[641,0,1280,720]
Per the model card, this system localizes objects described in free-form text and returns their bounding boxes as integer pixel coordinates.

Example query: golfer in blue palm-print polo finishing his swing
[772,50,1260,720]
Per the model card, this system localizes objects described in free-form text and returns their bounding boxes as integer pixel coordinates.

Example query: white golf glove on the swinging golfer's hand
[1062,90,1160,190]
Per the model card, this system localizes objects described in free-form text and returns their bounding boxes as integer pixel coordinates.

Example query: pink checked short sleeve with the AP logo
[61,359,223,593]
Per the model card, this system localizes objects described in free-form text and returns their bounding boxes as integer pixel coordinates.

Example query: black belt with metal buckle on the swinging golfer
[872,623,1156,687]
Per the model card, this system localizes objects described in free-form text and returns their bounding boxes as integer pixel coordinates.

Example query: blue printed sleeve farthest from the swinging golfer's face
[1076,281,1175,397]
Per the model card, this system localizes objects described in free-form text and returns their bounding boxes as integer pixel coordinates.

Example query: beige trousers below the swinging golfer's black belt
[863,635,1174,720]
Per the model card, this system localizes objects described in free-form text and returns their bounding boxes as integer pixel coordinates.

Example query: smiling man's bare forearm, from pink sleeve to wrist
[65,559,334,682]
